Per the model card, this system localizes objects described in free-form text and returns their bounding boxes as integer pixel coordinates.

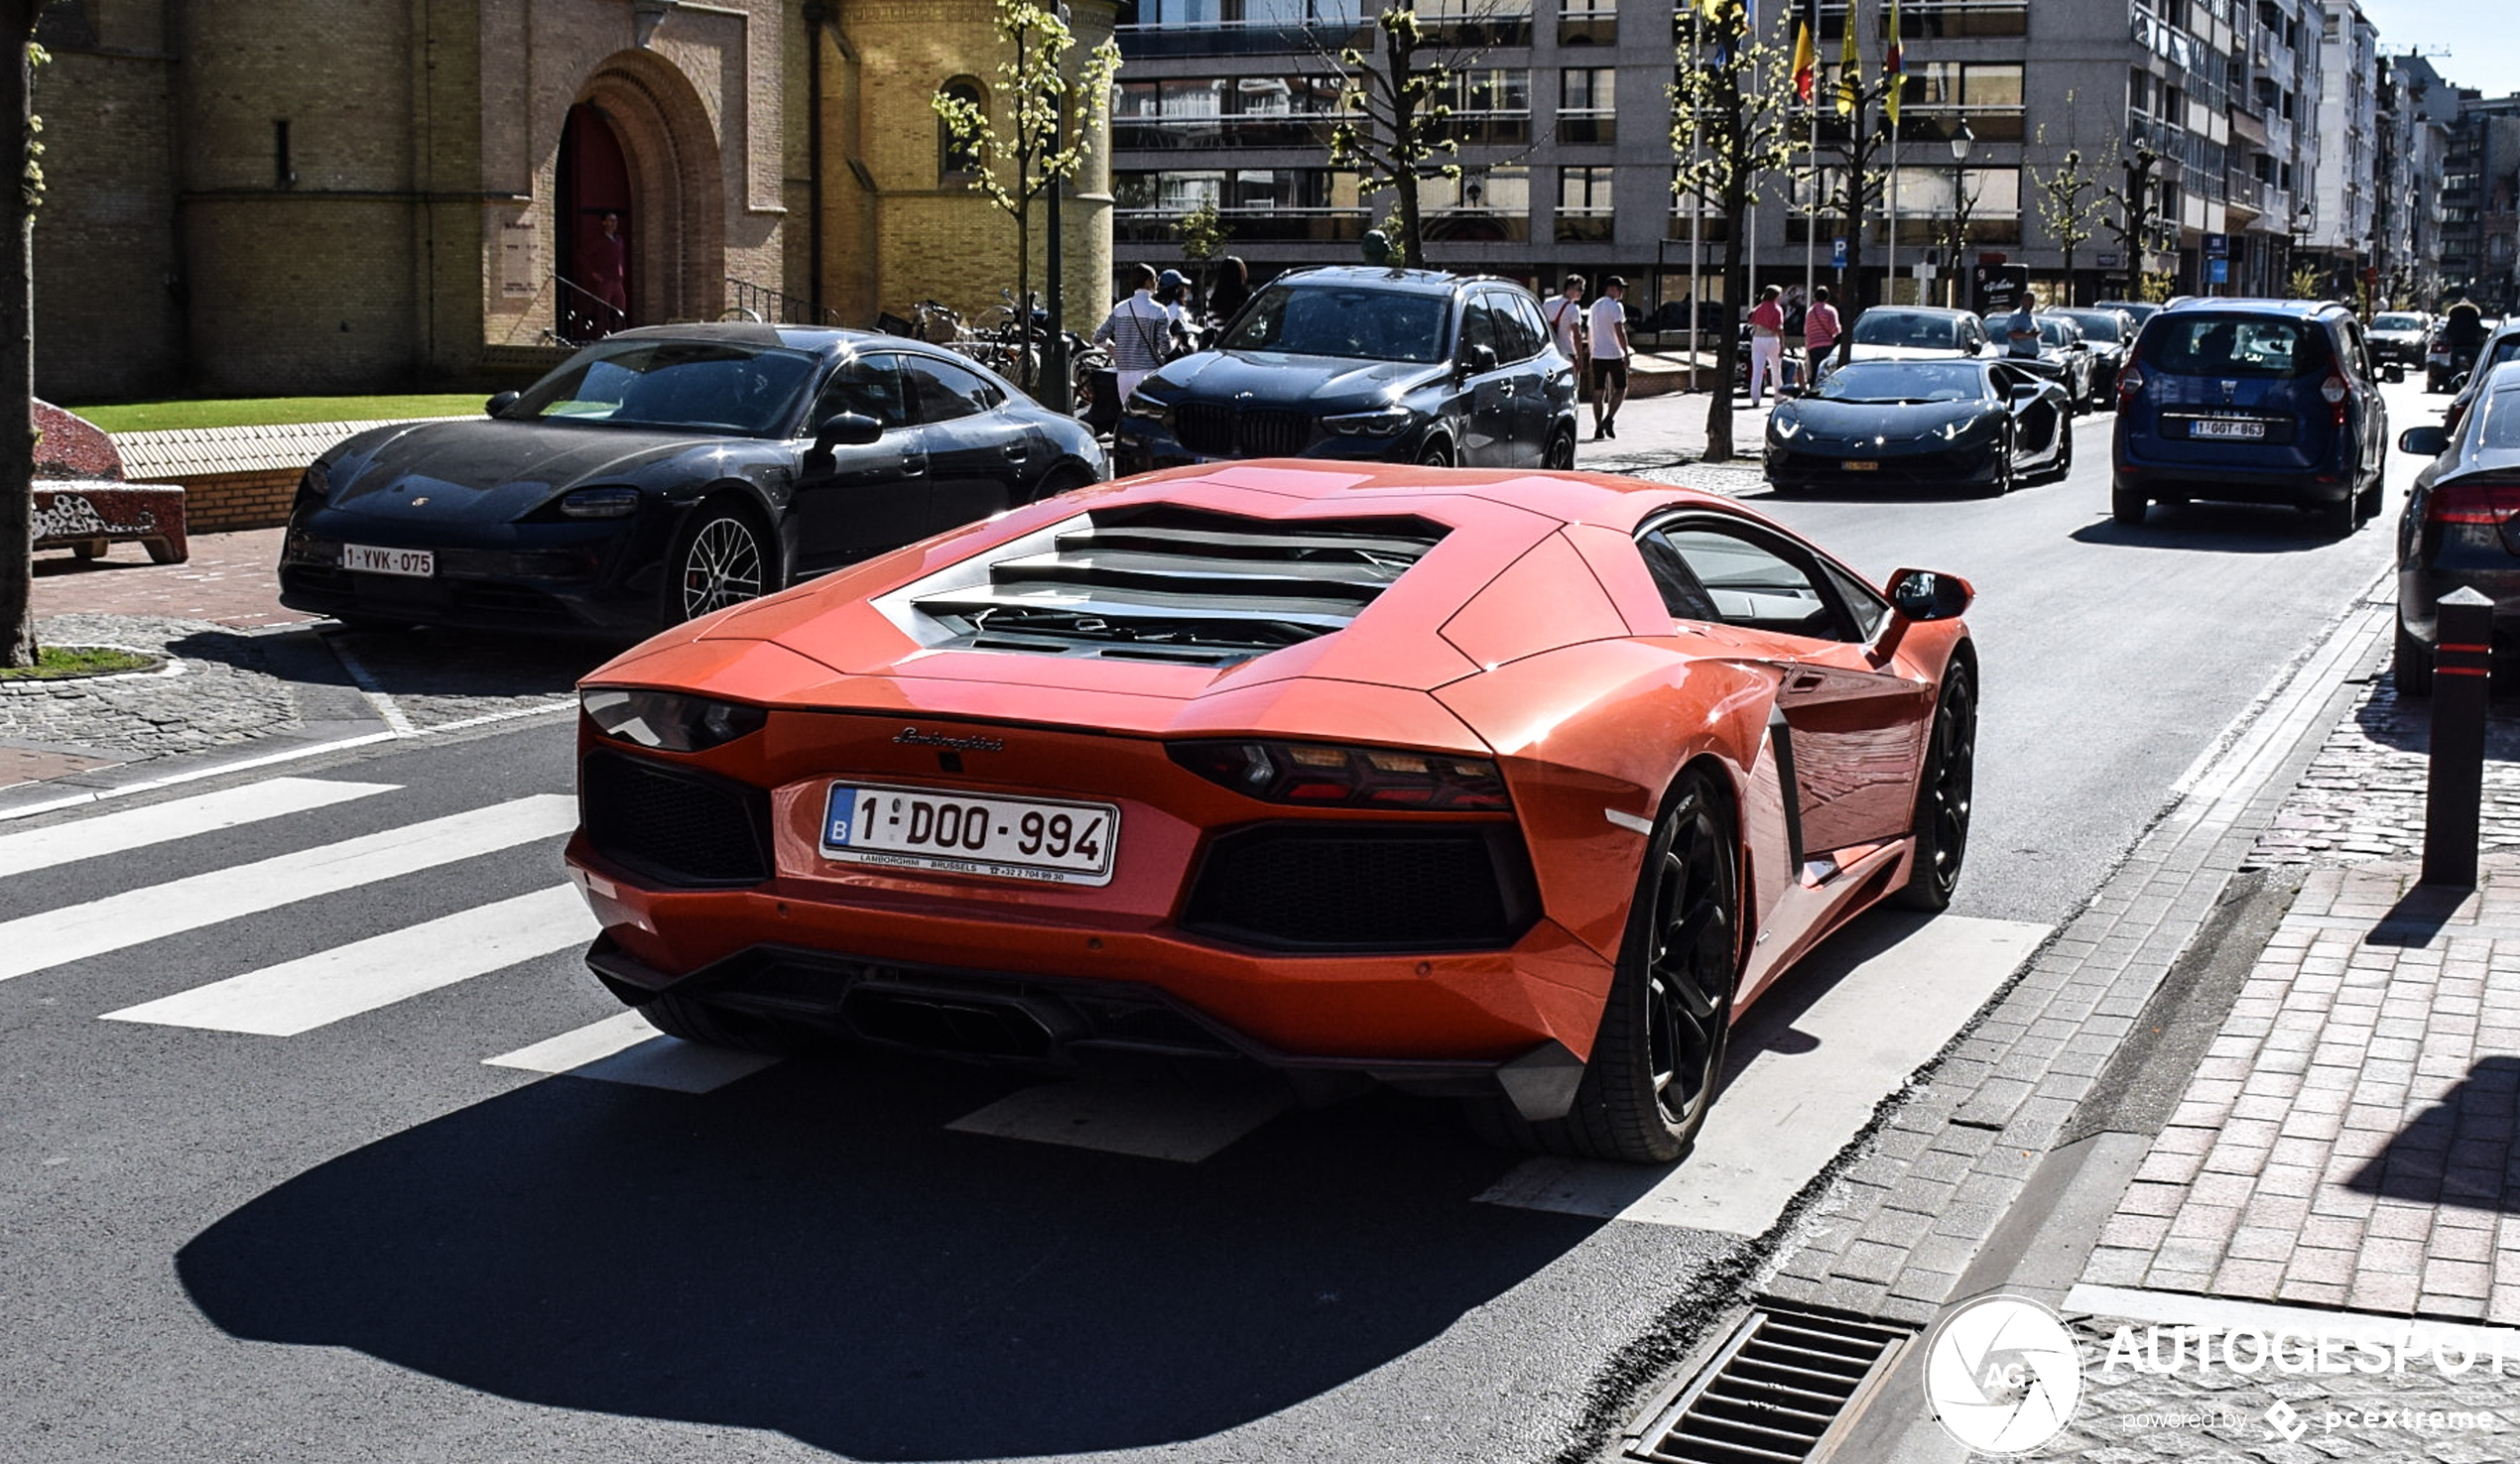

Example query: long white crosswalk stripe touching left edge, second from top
[0,793,577,980]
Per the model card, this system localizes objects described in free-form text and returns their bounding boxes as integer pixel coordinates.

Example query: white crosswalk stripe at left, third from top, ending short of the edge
[103,885,600,1038]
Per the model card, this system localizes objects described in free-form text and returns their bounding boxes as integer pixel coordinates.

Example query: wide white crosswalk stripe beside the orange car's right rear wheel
[1479,913,2049,1235]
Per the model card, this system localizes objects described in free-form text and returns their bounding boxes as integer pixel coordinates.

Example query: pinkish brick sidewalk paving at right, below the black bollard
[2084,857,2520,1325]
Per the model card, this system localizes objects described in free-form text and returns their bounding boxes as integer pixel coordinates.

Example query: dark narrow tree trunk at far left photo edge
[0,18,43,666]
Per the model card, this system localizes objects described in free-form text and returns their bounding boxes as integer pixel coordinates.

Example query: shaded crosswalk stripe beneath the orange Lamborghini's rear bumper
[945,1078,1293,1164]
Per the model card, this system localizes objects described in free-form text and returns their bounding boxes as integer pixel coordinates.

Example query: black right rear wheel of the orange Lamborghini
[1471,771,1741,1164]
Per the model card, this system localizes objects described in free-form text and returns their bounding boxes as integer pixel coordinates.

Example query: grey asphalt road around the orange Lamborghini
[0,380,2437,1464]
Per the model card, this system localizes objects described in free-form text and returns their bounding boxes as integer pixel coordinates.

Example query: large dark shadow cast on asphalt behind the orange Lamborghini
[177,1042,1602,1459]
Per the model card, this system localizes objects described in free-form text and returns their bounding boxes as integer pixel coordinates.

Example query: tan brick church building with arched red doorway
[36,0,1111,401]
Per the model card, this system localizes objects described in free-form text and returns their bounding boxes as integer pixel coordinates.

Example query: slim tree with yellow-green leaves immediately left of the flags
[1671,0,1805,463]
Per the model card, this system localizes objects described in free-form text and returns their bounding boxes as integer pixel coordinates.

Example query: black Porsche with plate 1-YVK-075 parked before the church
[280,325,1109,633]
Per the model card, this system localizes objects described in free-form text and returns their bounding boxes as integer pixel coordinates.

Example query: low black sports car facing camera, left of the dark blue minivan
[1767,360,2074,494]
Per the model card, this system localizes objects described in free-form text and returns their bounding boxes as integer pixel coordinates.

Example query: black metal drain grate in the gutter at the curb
[1625,1305,1915,1464]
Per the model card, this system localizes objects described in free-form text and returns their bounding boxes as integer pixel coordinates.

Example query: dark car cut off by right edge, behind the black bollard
[2397,360,2520,695]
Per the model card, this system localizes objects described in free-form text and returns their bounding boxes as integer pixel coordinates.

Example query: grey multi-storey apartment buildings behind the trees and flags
[1114,0,2447,309]
